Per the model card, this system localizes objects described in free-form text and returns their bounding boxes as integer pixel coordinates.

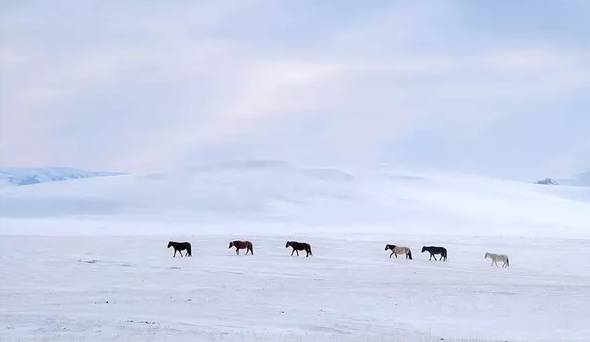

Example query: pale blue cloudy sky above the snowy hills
[0,0,590,179]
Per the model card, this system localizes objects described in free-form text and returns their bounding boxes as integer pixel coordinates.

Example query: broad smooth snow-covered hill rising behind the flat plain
[0,161,590,236]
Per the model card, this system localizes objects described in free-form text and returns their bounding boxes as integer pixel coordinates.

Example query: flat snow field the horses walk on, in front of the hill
[0,234,590,341]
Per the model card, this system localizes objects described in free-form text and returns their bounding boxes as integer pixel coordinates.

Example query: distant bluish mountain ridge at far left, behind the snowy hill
[0,167,124,186]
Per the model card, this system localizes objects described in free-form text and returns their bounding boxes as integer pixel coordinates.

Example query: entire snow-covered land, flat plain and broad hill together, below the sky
[0,161,590,341]
